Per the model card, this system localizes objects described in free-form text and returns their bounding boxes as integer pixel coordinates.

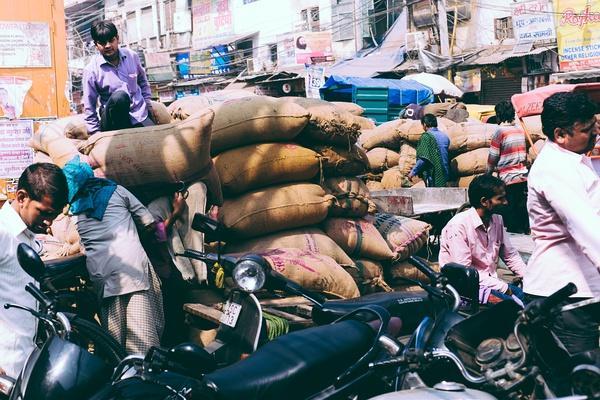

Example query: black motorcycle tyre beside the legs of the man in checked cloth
[65,314,128,367]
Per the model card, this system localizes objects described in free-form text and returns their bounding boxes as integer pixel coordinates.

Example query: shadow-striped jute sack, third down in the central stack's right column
[323,177,377,217]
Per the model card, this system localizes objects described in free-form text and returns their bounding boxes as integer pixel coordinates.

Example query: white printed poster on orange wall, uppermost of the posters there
[0,21,52,68]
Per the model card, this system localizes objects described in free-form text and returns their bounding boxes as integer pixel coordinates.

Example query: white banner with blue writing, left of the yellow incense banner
[511,0,556,43]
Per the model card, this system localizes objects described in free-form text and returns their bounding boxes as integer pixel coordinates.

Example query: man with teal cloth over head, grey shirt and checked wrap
[64,157,184,354]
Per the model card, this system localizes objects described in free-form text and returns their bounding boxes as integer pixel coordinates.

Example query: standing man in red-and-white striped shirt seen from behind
[487,100,529,233]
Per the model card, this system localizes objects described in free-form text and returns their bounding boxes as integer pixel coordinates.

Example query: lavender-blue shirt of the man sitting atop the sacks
[82,47,151,134]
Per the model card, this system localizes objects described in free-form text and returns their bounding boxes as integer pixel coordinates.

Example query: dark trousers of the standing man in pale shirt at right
[525,294,600,354]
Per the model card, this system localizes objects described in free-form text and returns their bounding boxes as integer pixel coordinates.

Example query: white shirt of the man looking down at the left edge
[0,202,42,378]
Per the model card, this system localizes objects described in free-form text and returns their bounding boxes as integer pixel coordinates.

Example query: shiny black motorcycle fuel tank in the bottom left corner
[10,336,112,400]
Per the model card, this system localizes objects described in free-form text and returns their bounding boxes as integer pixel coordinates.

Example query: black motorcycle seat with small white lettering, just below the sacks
[312,291,430,333]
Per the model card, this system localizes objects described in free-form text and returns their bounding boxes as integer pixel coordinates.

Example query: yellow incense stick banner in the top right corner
[554,0,600,72]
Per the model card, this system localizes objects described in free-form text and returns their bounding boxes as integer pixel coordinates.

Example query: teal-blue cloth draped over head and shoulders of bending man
[63,156,117,221]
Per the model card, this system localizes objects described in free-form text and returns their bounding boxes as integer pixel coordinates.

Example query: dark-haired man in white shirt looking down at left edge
[0,163,67,378]
